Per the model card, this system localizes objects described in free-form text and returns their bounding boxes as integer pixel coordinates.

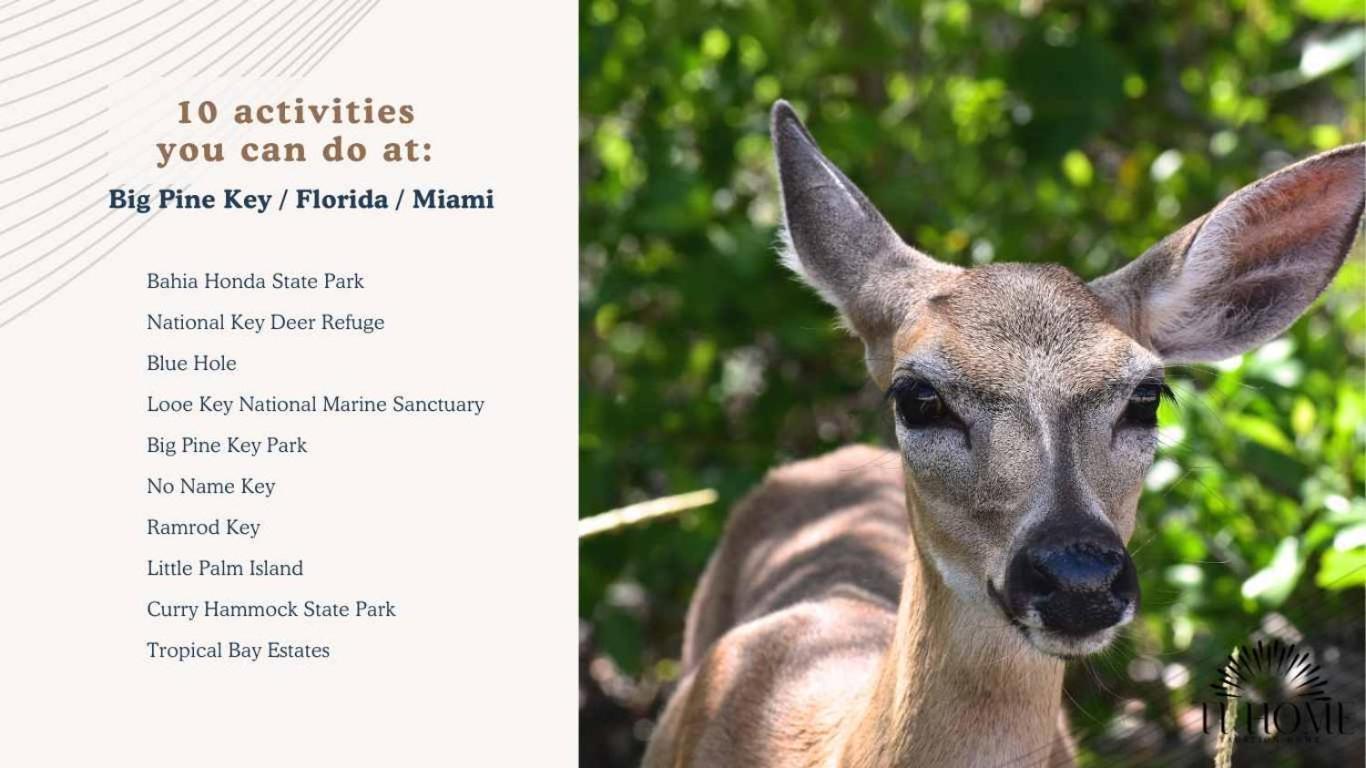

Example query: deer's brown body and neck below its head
[646,447,1068,768]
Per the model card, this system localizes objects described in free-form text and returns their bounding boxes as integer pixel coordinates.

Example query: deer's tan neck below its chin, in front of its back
[839,505,1063,768]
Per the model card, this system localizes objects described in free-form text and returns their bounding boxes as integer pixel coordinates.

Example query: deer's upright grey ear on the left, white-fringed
[772,101,945,340]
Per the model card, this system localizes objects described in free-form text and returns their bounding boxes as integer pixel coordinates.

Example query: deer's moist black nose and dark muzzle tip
[1005,532,1138,637]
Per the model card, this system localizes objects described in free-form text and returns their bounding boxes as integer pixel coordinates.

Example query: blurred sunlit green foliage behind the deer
[579,0,1366,759]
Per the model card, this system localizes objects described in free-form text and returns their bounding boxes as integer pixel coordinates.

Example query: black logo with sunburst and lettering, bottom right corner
[1201,640,1351,743]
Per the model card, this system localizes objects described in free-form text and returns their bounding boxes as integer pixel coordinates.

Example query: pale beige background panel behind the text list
[0,0,576,765]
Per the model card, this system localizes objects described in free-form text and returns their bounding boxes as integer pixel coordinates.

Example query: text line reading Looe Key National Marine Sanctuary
[148,395,488,415]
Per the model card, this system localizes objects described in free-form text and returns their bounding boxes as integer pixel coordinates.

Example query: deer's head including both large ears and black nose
[772,102,1366,657]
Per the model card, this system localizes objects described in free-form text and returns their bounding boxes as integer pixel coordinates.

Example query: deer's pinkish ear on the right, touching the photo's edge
[1090,143,1366,362]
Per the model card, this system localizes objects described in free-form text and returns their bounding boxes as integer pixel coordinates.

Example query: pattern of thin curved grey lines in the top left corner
[0,0,390,328]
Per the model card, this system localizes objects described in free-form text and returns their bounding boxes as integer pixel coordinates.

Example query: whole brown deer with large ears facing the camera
[643,101,1366,768]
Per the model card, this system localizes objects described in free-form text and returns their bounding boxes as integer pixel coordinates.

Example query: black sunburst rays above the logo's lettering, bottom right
[1210,640,1329,702]
